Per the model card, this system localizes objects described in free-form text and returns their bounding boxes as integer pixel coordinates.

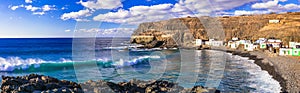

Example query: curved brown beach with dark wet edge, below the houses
[212,47,300,93]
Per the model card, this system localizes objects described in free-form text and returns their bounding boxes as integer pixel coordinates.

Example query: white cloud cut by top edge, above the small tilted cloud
[79,0,123,9]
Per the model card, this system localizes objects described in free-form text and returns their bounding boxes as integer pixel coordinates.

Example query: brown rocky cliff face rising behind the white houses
[132,12,300,47]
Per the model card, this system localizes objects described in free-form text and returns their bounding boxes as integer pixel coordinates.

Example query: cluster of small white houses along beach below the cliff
[196,38,300,56]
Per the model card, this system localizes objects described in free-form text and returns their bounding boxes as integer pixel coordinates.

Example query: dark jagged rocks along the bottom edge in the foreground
[1,74,220,93]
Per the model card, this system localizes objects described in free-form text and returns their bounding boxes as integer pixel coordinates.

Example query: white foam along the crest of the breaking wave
[0,56,160,72]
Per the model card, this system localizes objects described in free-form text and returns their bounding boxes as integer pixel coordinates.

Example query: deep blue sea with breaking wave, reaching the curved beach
[0,38,281,93]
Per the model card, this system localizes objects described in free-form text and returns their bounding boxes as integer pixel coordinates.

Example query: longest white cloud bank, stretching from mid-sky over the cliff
[93,0,257,24]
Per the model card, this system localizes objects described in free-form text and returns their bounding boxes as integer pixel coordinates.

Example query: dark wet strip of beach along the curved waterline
[212,47,300,93]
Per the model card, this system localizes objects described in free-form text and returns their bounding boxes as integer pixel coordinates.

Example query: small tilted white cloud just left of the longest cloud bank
[61,9,92,20]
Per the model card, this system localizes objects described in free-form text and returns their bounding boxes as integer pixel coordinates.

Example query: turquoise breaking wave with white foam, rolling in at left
[0,56,160,72]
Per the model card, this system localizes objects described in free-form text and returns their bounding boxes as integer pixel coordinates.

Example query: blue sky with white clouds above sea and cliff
[0,0,300,38]
